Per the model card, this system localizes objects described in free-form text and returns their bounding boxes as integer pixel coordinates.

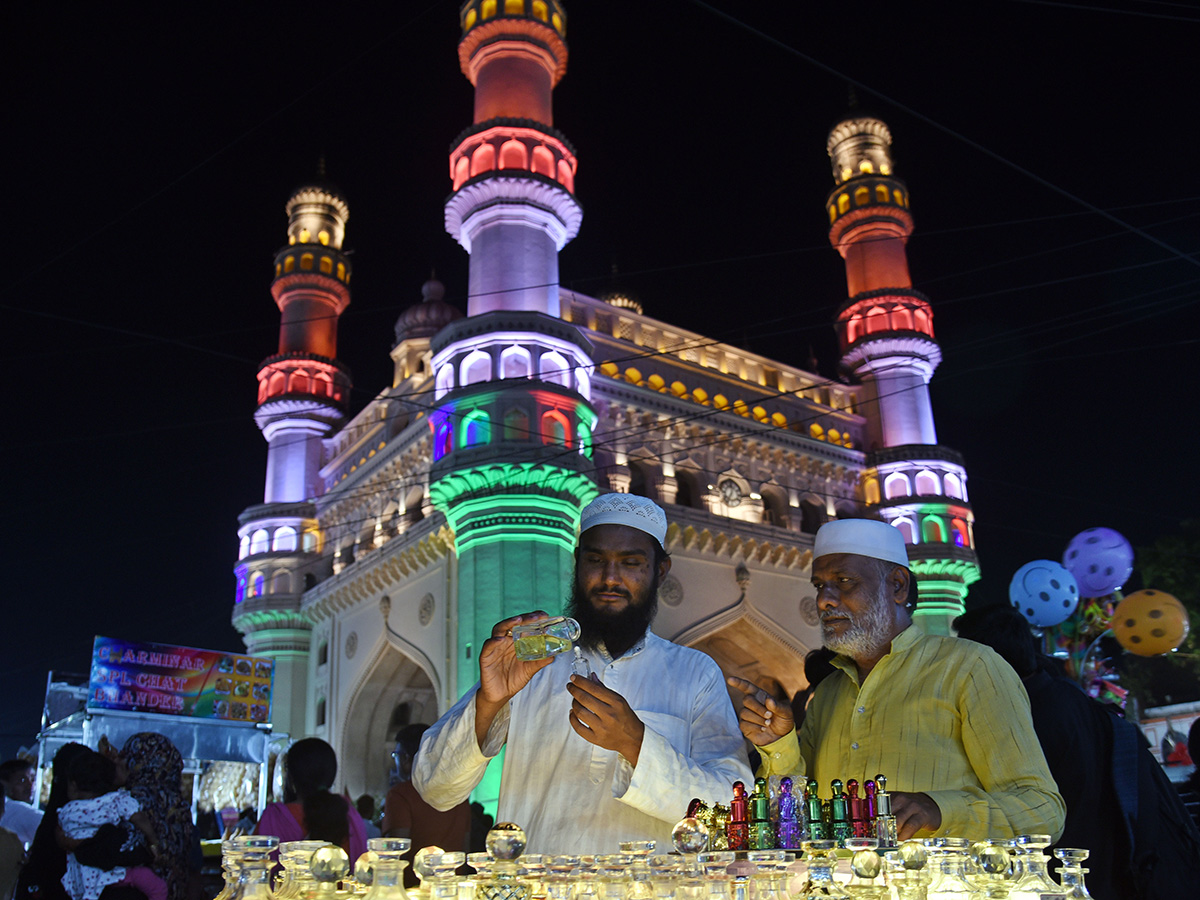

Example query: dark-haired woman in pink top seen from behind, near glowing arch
[256,738,367,864]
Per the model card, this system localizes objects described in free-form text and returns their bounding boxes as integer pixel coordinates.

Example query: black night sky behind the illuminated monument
[0,0,1200,757]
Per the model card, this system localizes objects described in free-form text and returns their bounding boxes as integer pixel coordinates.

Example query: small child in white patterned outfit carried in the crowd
[59,750,167,900]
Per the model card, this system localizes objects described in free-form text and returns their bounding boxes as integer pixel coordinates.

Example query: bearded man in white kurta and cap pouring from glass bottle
[413,494,751,853]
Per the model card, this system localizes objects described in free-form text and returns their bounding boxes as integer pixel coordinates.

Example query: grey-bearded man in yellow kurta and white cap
[728,518,1066,840]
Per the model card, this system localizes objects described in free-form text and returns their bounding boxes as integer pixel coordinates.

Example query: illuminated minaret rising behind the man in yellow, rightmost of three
[826,112,979,634]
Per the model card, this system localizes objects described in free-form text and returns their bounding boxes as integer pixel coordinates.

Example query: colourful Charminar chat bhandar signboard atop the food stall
[88,636,275,722]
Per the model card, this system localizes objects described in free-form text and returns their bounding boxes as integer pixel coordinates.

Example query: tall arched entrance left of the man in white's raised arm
[337,642,438,798]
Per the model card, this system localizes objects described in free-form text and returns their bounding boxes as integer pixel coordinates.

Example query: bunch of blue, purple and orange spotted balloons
[1008,528,1188,695]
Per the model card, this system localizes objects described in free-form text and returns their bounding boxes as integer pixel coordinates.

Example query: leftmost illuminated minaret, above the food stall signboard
[233,185,350,734]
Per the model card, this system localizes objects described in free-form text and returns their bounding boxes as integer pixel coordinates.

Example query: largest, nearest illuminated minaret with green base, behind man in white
[428,0,596,800]
